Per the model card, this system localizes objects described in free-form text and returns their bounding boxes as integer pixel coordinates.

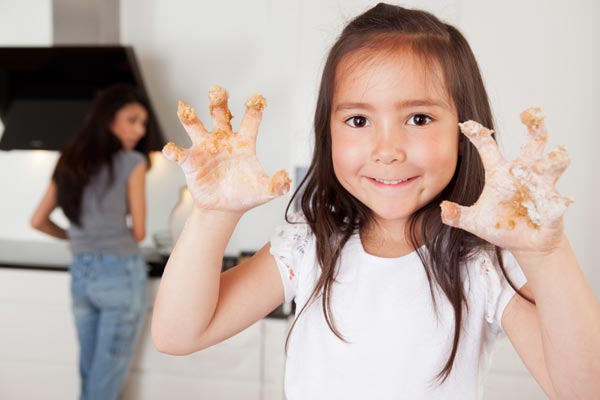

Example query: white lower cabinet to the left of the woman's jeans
[0,268,79,400]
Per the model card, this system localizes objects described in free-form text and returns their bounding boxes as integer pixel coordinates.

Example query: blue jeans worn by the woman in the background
[71,253,147,400]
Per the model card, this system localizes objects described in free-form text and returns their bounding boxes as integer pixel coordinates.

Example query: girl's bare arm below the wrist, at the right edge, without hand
[502,237,600,399]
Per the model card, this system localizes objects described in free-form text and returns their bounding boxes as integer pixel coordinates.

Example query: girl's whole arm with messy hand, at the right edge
[442,109,600,399]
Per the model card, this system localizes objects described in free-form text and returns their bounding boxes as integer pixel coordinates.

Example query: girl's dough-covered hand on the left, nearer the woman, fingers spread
[163,86,291,211]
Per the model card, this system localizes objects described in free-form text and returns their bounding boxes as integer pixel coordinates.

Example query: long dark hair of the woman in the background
[52,84,154,225]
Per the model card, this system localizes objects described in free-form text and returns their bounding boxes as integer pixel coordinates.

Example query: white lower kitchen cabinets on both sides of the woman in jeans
[0,268,289,400]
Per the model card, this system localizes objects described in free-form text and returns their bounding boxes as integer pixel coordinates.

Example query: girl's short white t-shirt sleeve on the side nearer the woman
[270,214,310,302]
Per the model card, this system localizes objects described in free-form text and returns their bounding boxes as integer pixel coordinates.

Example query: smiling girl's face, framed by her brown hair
[331,51,459,228]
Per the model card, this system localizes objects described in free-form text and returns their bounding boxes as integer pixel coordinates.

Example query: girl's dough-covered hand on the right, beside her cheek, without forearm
[441,108,573,254]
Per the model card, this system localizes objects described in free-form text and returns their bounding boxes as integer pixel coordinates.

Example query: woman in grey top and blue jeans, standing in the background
[31,85,151,400]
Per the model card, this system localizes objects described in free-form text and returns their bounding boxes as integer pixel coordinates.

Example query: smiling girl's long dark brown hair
[286,3,518,382]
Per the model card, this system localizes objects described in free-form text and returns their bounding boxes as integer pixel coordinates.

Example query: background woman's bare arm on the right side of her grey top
[127,163,146,242]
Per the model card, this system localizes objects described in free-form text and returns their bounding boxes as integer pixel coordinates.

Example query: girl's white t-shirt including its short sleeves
[271,216,526,400]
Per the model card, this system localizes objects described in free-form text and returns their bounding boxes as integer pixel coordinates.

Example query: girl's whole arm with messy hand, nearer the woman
[152,87,289,354]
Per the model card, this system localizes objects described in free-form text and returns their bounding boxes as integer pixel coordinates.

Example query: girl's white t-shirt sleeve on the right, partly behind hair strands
[480,250,527,334]
